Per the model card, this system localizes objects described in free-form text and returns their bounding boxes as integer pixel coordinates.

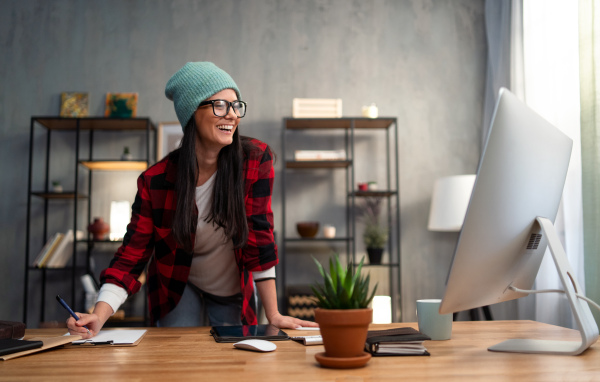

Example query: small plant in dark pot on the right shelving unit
[362,197,388,264]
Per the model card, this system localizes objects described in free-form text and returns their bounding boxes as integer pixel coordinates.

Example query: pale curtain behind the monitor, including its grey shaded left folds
[482,0,585,327]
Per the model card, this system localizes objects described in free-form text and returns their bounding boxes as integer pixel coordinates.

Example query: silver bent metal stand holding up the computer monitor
[488,217,598,355]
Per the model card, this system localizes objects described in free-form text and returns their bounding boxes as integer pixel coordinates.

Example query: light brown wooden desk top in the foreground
[0,321,600,382]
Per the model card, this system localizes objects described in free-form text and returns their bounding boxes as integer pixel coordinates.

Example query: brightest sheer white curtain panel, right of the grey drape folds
[511,0,584,327]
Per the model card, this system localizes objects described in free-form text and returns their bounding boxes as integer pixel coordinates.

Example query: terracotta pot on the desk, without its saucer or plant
[315,308,373,357]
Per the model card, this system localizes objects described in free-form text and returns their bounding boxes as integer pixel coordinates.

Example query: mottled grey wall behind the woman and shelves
[0,0,494,326]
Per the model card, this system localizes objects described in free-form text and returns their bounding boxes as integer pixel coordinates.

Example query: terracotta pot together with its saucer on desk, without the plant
[315,308,373,369]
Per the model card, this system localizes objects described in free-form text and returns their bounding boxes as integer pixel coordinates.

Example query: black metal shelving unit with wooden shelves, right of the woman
[280,117,402,322]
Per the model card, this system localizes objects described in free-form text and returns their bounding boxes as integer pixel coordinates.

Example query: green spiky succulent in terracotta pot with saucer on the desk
[312,254,377,368]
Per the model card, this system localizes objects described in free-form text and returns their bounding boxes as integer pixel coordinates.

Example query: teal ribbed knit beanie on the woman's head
[165,62,242,129]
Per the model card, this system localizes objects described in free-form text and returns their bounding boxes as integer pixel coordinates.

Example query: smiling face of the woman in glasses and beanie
[194,89,240,151]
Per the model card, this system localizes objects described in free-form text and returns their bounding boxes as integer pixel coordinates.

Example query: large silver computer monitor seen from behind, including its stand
[440,88,598,354]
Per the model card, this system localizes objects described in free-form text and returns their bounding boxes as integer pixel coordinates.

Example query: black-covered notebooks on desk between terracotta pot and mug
[365,327,431,356]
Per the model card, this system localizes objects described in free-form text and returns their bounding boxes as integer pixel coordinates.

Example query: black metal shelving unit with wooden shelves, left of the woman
[23,116,156,322]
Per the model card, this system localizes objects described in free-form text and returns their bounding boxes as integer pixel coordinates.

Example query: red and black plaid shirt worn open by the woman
[101,139,279,325]
